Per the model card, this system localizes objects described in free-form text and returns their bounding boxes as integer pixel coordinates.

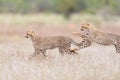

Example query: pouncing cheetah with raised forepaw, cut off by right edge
[74,23,120,53]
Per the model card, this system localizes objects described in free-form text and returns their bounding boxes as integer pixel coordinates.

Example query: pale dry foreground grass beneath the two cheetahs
[0,39,120,80]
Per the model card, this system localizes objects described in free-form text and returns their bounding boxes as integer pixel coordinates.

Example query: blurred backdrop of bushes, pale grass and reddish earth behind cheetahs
[0,0,120,39]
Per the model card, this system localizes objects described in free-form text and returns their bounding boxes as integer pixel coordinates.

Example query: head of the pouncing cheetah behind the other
[80,23,97,37]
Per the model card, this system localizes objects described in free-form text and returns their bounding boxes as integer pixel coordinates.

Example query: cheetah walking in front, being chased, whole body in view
[25,31,79,58]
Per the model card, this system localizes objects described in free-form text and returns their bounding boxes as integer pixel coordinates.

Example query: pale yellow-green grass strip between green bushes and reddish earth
[0,13,120,26]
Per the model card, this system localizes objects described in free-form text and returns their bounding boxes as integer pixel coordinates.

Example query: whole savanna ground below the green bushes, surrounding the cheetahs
[0,14,120,80]
